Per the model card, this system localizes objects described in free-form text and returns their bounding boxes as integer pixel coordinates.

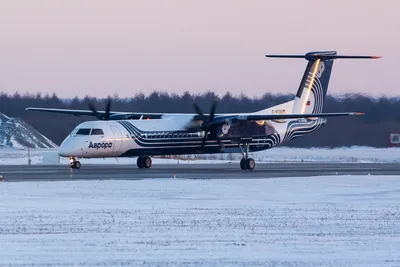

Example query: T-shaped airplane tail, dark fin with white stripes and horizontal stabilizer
[266,51,380,114]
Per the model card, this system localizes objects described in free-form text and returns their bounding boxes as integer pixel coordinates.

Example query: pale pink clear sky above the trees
[0,0,400,97]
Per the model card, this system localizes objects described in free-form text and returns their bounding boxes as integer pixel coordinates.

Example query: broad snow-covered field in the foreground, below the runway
[0,176,400,266]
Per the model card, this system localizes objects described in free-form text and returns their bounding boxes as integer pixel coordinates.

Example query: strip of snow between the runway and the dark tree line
[0,147,400,165]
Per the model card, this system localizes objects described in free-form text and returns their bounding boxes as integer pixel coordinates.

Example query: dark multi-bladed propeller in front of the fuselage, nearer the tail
[186,101,223,152]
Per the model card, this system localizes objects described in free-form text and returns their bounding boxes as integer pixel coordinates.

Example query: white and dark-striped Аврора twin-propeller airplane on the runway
[26,51,380,170]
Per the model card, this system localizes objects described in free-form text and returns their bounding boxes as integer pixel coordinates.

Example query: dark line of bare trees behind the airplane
[0,91,400,147]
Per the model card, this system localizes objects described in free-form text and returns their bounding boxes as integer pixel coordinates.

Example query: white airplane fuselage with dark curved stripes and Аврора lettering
[58,108,325,158]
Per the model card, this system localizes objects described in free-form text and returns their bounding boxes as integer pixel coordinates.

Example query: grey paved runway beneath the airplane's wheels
[0,163,400,182]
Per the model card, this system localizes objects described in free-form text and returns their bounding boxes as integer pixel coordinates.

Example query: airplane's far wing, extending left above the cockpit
[25,107,164,120]
